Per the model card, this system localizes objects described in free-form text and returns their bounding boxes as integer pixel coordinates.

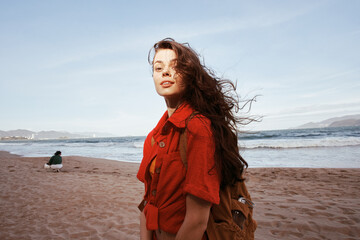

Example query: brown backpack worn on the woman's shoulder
[179,123,257,240]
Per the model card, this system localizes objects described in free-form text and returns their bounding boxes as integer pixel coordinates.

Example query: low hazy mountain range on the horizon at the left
[0,129,113,140]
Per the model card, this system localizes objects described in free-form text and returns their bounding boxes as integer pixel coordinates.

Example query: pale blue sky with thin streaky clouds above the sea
[0,0,360,136]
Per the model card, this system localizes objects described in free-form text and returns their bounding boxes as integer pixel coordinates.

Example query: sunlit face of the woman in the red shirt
[153,49,185,105]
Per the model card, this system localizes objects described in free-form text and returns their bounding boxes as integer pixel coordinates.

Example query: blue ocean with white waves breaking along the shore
[0,127,360,168]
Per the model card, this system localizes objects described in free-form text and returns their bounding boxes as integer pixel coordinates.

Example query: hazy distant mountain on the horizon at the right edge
[296,114,360,128]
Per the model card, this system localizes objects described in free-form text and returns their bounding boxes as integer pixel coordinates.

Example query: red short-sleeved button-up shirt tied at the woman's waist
[137,104,220,234]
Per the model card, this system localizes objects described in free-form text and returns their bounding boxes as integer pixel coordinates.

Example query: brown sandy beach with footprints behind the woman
[0,152,360,240]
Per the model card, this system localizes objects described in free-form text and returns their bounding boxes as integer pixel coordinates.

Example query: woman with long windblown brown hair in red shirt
[137,38,247,240]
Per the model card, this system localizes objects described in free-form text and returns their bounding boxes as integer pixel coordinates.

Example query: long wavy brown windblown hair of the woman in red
[148,38,253,187]
